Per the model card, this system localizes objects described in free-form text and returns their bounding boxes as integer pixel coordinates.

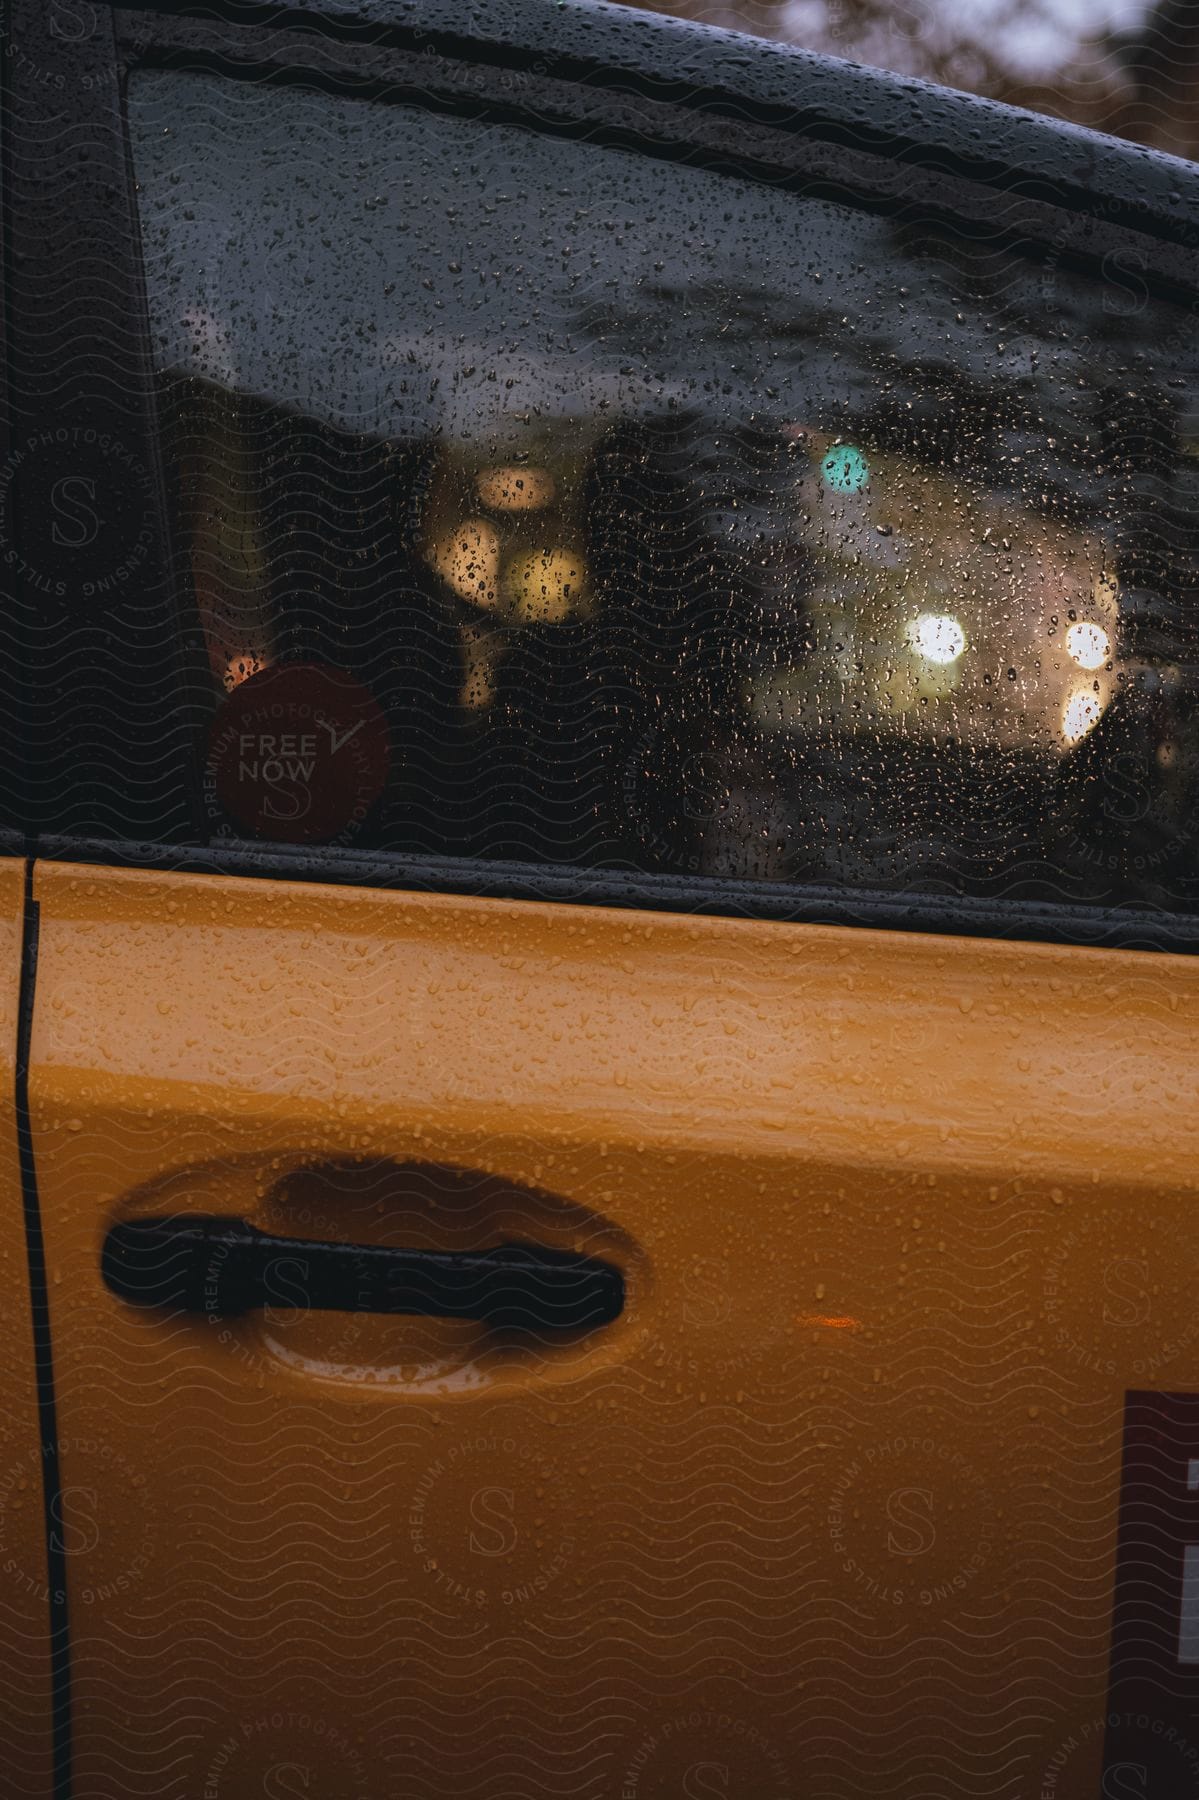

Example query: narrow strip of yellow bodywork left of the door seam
[0,859,50,1800]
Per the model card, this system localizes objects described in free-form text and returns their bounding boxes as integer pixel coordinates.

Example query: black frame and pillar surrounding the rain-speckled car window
[0,0,1199,950]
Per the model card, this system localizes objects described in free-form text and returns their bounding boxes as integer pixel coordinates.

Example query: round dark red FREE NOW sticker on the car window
[205,662,389,844]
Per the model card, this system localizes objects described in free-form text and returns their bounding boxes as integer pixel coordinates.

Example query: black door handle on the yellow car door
[101,1213,625,1330]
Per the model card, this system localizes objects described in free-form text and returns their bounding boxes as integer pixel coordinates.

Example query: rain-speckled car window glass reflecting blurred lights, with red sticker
[128,70,1199,909]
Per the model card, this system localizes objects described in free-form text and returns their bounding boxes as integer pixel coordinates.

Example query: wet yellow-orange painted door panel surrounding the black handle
[31,866,1199,1800]
